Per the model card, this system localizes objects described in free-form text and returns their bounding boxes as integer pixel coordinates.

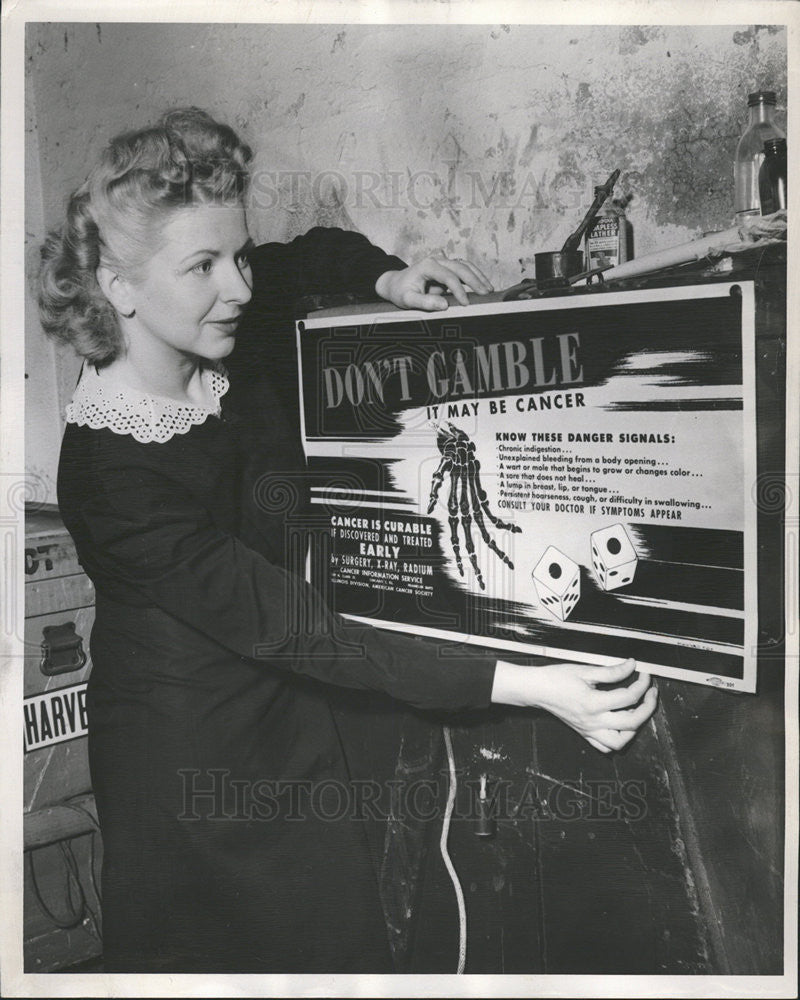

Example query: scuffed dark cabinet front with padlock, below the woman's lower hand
[407,714,711,975]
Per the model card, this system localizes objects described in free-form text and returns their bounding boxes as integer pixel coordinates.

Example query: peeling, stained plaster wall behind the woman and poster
[27,15,786,482]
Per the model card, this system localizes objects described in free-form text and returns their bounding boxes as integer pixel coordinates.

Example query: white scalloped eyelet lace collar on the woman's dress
[66,363,228,444]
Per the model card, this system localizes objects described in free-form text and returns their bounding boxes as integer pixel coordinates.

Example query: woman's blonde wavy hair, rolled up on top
[39,108,252,363]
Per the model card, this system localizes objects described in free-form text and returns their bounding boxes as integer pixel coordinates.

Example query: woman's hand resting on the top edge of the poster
[375,256,494,312]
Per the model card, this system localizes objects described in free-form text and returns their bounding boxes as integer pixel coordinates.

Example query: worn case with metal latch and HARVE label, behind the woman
[23,511,102,972]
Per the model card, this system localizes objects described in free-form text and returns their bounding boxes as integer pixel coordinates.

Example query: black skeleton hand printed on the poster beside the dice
[428,423,522,590]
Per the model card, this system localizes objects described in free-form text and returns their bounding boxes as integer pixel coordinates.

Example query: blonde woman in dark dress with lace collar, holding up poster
[40,109,655,972]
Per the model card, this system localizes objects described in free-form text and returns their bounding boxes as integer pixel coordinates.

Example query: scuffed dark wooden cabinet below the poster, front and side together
[390,670,783,975]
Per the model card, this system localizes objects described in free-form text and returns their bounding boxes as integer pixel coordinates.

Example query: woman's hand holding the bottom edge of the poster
[492,660,657,753]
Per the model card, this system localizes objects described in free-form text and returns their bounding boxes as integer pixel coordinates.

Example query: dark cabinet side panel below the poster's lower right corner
[660,663,784,975]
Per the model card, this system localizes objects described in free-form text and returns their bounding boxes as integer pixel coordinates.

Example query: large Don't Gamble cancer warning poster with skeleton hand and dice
[298,283,757,691]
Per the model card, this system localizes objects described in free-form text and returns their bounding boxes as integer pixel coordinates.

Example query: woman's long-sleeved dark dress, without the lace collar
[59,232,493,972]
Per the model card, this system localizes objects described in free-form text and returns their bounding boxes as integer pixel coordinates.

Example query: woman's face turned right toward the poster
[127,204,253,361]
